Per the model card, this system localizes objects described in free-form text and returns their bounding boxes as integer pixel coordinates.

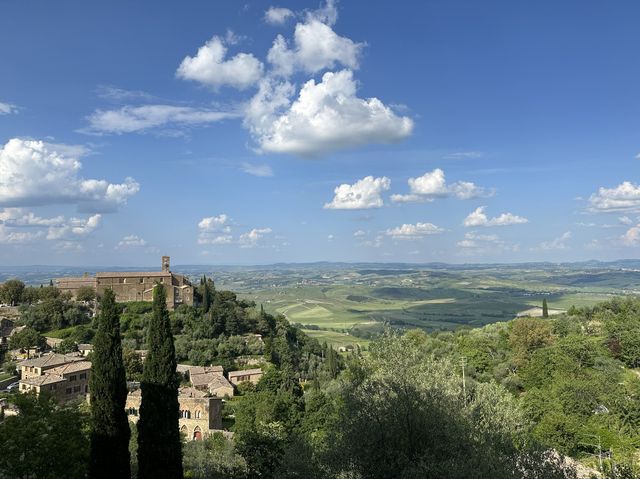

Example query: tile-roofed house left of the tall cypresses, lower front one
[19,355,91,402]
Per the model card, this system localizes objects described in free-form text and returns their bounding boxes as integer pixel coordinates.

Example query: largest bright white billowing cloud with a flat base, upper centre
[245,70,413,156]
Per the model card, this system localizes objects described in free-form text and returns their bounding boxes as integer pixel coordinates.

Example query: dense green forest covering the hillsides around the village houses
[0,278,640,479]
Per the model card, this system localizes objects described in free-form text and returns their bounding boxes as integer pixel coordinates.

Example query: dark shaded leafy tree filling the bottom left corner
[0,394,89,479]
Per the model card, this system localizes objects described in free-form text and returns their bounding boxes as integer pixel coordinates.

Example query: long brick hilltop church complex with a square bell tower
[56,256,194,309]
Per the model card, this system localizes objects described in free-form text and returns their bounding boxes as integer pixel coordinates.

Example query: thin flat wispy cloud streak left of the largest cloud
[81,105,240,134]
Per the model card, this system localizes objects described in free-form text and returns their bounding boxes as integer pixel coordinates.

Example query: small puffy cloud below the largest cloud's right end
[324,176,391,210]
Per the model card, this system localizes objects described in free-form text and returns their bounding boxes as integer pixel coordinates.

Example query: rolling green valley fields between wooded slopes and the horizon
[224,265,640,346]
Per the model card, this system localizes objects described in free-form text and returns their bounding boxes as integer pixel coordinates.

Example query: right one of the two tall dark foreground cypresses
[138,284,183,479]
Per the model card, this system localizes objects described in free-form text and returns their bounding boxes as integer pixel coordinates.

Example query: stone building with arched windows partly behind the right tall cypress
[125,388,222,441]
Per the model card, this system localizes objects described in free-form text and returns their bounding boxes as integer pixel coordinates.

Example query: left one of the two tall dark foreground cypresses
[89,289,131,479]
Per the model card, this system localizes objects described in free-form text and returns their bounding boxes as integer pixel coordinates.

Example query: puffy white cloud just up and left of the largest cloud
[176,36,263,90]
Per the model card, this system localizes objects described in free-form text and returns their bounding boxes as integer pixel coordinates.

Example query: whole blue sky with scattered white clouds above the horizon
[0,0,640,266]
